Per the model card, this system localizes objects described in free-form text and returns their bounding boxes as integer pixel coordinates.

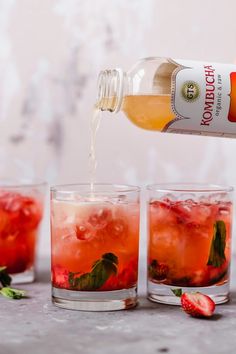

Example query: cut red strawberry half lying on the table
[180,292,215,317]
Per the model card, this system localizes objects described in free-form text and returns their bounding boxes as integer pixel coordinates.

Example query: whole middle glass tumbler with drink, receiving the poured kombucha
[51,184,139,311]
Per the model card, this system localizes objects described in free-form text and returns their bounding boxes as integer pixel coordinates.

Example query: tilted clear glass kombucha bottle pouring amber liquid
[96,57,236,137]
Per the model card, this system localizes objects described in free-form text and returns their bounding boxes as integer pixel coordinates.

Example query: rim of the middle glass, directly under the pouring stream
[50,183,141,194]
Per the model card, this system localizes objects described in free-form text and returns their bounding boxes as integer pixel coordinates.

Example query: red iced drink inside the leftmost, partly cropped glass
[0,190,43,282]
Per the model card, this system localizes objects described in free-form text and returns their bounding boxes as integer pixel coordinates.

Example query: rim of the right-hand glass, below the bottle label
[146,183,234,193]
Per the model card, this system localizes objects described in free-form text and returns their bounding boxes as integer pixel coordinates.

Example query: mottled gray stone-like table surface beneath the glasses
[0,258,236,354]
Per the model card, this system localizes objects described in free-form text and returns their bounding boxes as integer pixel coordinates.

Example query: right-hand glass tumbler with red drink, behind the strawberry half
[147,184,233,305]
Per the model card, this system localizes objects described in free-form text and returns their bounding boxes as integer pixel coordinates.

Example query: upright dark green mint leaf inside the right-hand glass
[207,220,226,267]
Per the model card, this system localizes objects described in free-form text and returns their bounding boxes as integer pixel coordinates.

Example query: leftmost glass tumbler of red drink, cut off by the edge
[0,180,46,284]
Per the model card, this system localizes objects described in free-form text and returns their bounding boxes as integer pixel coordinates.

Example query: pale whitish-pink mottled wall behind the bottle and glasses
[0,0,236,253]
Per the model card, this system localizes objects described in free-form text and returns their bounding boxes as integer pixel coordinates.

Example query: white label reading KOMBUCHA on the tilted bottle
[164,60,236,136]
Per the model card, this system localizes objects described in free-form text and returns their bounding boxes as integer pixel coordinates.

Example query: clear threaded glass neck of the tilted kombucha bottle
[96,69,125,113]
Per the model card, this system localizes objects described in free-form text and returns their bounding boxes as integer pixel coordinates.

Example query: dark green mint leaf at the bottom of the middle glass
[68,253,118,291]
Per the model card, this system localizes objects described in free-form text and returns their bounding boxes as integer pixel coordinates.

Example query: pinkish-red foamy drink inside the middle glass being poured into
[51,185,139,309]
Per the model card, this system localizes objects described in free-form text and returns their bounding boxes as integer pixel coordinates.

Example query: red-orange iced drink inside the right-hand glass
[148,185,232,304]
